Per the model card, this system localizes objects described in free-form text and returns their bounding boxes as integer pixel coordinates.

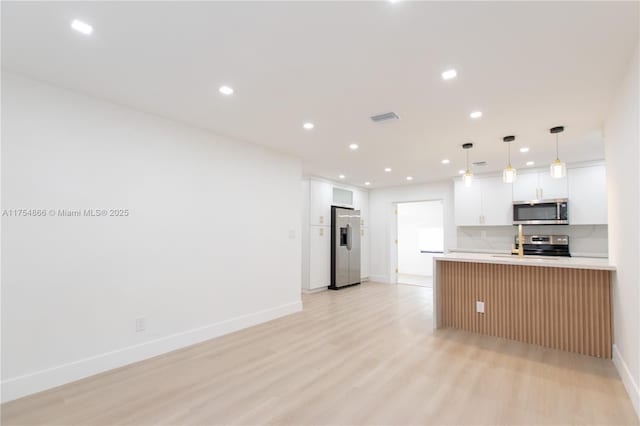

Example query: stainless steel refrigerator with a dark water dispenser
[329,206,360,290]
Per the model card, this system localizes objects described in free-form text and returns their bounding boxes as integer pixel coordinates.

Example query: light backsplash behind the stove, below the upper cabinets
[457,225,608,257]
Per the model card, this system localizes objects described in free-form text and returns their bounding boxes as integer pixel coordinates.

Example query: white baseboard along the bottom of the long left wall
[2,301,302,402]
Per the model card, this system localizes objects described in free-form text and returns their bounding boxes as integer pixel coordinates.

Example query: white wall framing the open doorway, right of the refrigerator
[369,180,456,283]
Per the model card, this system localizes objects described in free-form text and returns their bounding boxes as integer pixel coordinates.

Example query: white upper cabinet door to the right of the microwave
[567,166,607,225]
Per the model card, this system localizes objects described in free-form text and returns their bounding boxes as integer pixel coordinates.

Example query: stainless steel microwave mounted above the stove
[513,198,569,225]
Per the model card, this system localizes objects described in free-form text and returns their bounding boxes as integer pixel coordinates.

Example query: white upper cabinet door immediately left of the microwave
[478,178,513,226]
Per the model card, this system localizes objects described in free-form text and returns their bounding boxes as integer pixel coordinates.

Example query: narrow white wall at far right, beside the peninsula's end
[604,45,640,416]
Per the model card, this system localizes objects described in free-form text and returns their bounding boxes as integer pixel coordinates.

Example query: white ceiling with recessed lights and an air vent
[2,1,639,187]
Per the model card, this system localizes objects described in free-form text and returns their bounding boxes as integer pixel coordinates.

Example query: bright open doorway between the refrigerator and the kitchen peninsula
[396,200,444,287]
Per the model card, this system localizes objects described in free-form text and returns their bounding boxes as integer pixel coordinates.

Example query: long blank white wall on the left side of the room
[2,73,301,400]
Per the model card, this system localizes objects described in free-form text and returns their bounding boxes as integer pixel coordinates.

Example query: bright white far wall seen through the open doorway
[397,200,443,277]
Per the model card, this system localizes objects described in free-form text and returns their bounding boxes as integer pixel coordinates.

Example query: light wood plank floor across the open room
[2,283,638,425]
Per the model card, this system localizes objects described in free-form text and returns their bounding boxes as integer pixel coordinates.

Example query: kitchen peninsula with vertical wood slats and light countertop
[433,252,615,358]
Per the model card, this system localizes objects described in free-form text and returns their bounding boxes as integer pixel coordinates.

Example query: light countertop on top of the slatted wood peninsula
[433,252,616,271]
